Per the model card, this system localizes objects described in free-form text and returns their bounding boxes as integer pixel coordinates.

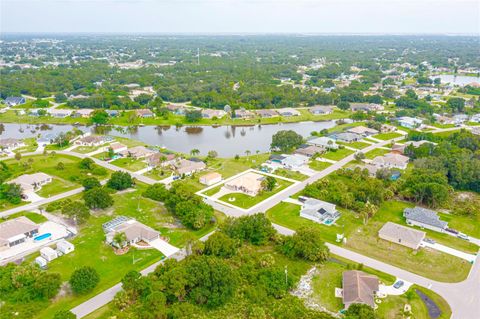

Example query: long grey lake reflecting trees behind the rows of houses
[0,121,335,157]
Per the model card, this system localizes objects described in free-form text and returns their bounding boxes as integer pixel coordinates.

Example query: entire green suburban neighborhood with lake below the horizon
[0,33,480,319]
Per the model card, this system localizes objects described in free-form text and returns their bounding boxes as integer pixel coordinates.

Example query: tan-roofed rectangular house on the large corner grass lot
[378,222,425,249]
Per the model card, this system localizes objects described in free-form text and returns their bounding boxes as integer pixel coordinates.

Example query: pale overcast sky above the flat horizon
[0,0,480,34]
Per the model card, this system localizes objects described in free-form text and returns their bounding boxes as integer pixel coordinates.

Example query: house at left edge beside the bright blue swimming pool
[0,216,40,251]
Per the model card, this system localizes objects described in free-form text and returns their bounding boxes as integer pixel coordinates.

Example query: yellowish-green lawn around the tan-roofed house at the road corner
[346,202,471,282]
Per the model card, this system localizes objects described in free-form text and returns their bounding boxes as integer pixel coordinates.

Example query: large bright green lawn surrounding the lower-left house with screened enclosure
[31,184,223,318]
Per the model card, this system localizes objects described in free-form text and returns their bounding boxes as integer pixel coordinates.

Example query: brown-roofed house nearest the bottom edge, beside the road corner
[342,270,378,309]
